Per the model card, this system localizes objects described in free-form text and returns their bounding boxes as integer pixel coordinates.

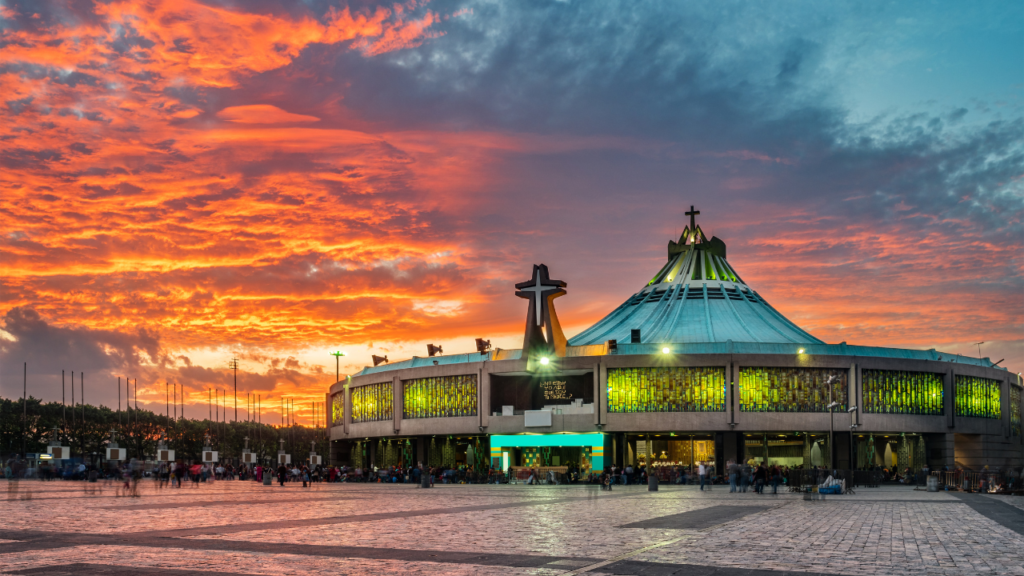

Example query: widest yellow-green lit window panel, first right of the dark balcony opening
[608,367,725,412]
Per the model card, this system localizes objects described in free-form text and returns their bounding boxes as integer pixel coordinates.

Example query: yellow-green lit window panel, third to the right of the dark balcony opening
[861,370,945,416]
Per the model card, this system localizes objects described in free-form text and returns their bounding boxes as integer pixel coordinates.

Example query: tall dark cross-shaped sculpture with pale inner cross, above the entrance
[515,264,565,369]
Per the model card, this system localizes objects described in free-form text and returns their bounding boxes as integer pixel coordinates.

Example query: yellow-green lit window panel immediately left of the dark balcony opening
[401,374,476,418]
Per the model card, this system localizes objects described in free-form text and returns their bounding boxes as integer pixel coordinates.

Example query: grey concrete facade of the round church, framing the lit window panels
[328,354,1024,469]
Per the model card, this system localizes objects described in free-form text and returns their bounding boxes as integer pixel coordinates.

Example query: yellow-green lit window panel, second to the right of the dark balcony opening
[739,368,848,412]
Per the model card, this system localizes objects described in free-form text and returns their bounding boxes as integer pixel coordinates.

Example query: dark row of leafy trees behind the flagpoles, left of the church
[0,397,329,462]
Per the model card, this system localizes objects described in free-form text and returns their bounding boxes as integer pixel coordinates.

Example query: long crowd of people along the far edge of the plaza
[8,457,1022,495]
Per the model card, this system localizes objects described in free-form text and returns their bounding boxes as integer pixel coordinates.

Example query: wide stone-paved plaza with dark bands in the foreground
[0,481,1024,576]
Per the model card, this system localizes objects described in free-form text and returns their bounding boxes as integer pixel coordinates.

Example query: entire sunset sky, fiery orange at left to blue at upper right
[0,0,1024,422]
